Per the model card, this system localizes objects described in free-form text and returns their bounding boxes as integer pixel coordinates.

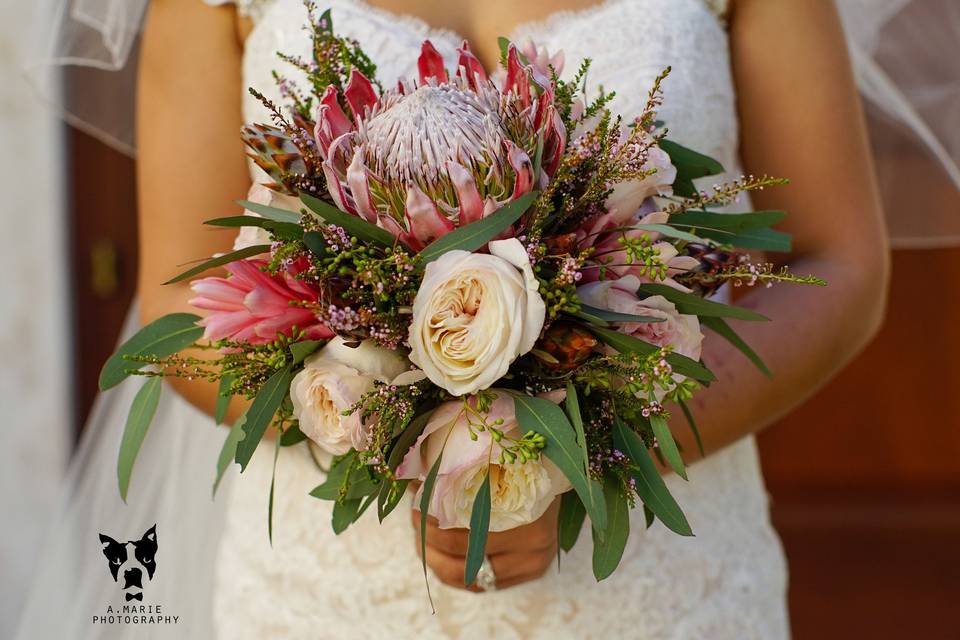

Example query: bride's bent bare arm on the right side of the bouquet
[674,0,889,457]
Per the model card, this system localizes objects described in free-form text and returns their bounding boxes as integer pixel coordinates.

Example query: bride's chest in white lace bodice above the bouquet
[244,0,736,163]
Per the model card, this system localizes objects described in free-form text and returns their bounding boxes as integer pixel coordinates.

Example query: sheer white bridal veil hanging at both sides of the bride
[16,0,960,640]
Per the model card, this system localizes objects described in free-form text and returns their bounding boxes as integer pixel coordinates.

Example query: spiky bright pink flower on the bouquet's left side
[190,258,334,344]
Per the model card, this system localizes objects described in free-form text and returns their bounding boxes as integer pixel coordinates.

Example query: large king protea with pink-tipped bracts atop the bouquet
[314,41,566,251]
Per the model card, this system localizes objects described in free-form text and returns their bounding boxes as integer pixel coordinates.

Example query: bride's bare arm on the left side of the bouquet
[137,0,250,417]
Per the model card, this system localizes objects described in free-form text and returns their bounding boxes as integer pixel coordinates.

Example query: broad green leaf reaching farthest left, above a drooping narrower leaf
[100,313,203,391]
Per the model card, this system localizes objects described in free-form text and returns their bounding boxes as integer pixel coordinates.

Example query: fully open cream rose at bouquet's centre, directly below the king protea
[409,238,546,396]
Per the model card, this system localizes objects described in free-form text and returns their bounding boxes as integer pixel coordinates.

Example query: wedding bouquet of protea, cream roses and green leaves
[107,3,822,585]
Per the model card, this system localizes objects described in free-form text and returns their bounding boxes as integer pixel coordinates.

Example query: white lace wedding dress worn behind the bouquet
[208,0,789,640]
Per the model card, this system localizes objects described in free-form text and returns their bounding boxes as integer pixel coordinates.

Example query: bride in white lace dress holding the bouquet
[16,0,888,640]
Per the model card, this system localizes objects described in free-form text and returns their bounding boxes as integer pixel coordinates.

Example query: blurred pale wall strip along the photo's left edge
[0,2,73,638]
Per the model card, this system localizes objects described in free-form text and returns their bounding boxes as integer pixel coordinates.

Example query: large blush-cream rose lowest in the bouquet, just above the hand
[397,391,570,531]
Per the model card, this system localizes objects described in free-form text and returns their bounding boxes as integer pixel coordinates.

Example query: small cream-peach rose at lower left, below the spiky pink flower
[290,336,423,455]
